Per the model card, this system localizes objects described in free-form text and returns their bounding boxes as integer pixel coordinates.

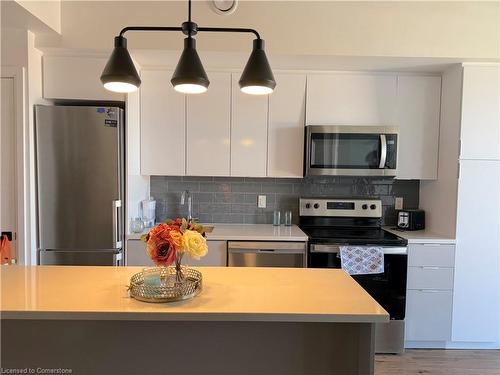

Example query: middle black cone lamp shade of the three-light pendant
[170,36,210,94]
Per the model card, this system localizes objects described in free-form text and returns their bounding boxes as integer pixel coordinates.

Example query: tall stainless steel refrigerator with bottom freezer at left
[35,105,124,265]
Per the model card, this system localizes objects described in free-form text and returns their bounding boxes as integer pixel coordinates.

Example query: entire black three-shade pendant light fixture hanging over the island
[101,0,276,95]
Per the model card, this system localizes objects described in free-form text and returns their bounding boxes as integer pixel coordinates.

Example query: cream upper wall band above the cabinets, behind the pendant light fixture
[36,1,500,58]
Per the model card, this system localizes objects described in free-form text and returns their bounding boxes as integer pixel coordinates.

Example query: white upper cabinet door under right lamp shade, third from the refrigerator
[231,74,269,177]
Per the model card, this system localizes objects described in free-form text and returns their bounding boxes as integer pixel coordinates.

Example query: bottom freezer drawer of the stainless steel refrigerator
[38,250,122,266]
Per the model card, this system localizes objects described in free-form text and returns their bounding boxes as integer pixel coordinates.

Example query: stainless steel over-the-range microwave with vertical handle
[305,125,399,176]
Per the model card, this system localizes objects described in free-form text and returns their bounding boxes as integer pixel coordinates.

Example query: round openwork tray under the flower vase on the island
[128,267,202,303]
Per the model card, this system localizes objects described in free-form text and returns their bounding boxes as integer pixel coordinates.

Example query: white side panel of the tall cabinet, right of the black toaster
[419,65,462,237]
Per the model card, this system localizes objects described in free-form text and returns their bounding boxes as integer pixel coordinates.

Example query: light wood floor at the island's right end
[375,349,500,375]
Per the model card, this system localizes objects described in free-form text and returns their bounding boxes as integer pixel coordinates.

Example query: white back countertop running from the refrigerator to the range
[127,223,308,241]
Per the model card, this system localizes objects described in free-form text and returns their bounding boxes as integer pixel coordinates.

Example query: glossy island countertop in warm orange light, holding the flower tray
[0,266,389,323]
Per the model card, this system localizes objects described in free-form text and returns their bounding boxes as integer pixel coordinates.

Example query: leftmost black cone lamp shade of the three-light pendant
[101,36,141,93]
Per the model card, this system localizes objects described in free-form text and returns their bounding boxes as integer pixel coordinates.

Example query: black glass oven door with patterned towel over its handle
[308,243,408,320]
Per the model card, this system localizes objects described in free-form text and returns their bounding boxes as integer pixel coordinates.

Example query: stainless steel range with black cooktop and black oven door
[300,198,407,353]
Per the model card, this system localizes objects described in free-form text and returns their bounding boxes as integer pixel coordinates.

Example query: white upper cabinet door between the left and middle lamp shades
[140,70,186,176]
